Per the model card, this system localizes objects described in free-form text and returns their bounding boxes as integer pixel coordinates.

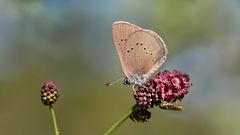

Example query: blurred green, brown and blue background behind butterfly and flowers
[0,0,240,135]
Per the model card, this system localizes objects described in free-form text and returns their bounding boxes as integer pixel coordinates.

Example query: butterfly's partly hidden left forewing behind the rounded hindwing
[112,21,142,78]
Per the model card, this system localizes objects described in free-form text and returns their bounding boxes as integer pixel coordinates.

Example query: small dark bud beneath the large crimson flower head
[130,109,151,123]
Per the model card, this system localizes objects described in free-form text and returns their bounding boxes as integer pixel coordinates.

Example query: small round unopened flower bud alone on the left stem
[40,81,59,105]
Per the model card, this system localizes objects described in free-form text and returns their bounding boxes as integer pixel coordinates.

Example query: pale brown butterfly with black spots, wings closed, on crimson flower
[109,21,168,85]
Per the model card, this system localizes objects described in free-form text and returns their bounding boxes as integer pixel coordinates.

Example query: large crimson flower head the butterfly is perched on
[134,70,191,108]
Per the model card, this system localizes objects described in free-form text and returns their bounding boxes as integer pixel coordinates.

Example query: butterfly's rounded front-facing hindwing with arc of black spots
[121,29,167,84]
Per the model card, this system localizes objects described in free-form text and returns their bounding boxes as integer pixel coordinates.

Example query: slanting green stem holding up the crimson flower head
[104,105,138,135]
